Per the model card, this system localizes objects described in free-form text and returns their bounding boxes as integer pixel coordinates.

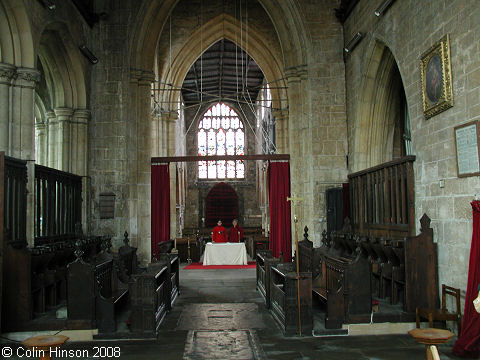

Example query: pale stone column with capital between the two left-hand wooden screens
[10,68,40,246]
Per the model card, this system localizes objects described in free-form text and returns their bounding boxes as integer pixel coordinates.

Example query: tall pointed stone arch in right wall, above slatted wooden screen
[351,40,406,171]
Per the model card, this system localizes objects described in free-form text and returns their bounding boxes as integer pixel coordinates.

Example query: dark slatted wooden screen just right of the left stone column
[35,165,82,246]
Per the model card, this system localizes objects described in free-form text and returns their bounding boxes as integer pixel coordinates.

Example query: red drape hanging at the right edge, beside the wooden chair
[453,201,480,358]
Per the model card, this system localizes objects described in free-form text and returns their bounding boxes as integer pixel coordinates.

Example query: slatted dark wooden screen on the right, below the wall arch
[348,155,415,236]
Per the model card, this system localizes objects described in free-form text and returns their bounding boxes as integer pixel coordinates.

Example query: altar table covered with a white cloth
[203,243,248,265]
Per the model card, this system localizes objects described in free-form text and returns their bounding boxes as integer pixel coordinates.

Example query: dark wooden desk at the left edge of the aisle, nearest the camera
[130,262,171,338]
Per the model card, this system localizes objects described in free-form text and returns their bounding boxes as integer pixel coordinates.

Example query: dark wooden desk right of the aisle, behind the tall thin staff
[270,263,313,335]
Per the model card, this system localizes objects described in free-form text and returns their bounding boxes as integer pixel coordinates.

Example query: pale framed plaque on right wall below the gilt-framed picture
[454,121,480,177]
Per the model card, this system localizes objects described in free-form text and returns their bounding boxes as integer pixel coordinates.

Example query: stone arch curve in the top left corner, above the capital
[0,0,35,68]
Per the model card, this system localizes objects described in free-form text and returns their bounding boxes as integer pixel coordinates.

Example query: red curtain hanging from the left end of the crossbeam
[152,164,170,260]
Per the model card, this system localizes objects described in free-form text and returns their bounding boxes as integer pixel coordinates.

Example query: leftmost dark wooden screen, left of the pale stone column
[3,156,27,247]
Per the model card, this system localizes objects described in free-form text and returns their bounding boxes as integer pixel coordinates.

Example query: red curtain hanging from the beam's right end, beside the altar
[269,162,292,262]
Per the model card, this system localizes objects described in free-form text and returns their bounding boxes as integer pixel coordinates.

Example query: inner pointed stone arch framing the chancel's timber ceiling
[158,14,287,110]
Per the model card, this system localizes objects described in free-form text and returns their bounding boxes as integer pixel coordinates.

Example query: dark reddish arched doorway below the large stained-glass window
[205,182,238,227]
